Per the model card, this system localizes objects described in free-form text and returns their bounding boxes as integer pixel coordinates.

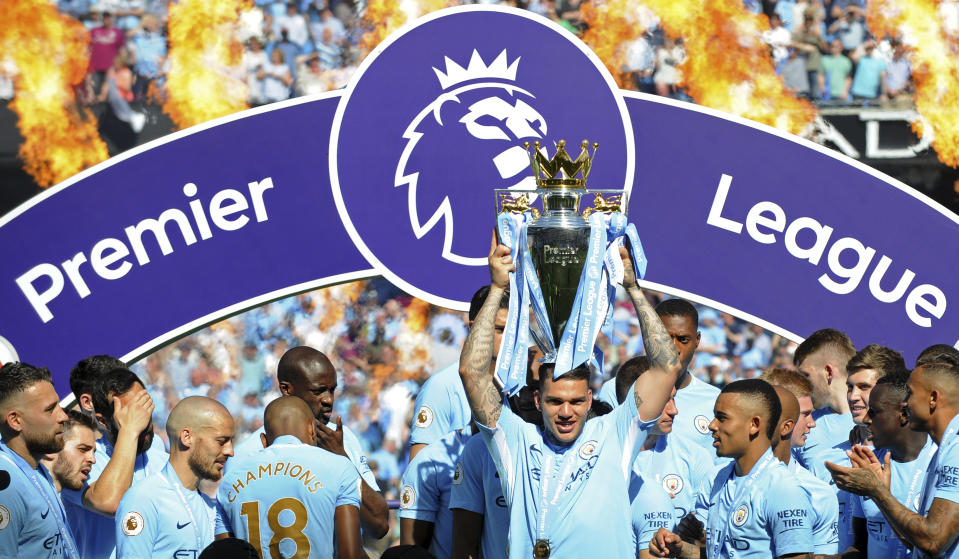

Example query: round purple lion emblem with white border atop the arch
[329,6,635,306]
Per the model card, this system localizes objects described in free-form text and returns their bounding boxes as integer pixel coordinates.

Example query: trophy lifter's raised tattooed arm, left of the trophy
[460,238,515,429]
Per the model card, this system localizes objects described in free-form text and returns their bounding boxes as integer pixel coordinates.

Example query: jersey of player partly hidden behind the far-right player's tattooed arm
[852,437,937,559]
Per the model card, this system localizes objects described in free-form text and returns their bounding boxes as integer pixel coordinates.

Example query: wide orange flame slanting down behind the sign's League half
[644,0,815,134]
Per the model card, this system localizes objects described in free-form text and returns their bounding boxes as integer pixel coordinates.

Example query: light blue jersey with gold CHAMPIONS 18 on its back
[215,435,360,559]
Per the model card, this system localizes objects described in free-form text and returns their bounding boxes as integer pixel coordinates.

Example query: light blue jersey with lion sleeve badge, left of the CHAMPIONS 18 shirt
[115,462,216,559]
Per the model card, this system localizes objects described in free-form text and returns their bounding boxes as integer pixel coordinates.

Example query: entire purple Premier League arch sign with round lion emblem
[0,6,959,394]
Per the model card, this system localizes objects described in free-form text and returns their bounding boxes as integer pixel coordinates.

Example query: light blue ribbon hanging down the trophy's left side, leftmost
[496,212,542,396]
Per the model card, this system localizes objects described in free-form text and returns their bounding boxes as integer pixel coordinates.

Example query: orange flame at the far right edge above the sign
[866,0,959,167]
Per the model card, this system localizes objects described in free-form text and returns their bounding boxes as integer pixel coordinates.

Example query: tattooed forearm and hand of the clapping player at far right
[826,462,959,557]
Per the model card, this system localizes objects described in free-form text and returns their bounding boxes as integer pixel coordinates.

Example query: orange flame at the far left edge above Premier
[0,0,109,188]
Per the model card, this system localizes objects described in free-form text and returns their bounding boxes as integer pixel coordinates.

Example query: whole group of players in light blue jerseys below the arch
[0,246,959,559]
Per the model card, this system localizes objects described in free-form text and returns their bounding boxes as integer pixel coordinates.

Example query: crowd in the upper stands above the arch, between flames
[0,0,940,118]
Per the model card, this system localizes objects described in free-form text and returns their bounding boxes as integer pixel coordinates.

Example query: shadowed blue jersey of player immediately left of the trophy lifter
[450,434,509,559]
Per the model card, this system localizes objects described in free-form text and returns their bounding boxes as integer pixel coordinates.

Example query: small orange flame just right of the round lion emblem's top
[580,0,646,87]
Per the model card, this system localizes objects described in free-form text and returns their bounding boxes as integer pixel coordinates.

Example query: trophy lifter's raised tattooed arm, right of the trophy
[619,248,683,420]
